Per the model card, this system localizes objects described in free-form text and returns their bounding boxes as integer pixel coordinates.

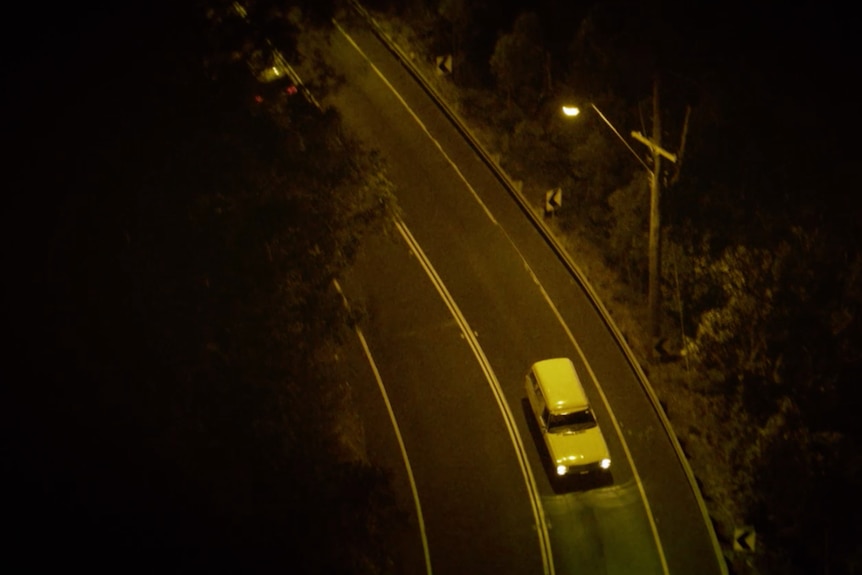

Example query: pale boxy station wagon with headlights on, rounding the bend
[526,357,611,477]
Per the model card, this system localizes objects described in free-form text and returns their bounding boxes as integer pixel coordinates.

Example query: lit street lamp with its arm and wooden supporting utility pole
[563,86,676,347]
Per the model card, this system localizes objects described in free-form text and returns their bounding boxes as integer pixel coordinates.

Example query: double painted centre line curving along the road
[396,220,555,575]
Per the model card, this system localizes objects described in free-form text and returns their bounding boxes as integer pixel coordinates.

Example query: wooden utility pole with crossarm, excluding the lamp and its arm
[632,76,676,349]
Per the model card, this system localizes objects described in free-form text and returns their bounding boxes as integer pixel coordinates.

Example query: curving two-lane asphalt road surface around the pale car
[320,12,721,574]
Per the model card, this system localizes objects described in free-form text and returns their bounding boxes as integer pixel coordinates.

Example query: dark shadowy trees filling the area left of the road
[0,1,402,574]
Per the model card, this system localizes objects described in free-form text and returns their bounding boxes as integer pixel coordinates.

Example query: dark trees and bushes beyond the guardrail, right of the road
[365,0,862,574]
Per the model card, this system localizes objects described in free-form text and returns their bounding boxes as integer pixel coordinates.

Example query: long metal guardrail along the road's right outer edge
[348,0,728,575]
